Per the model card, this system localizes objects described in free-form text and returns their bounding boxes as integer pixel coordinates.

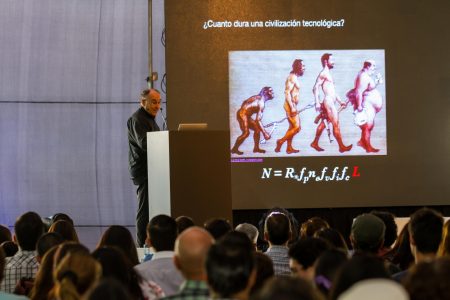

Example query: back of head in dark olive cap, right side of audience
[350,214,386,254]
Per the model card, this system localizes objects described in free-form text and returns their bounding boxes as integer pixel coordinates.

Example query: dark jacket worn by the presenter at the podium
[127,107,159,185]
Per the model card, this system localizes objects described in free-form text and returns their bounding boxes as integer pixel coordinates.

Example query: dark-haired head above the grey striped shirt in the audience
[264,212,291,245]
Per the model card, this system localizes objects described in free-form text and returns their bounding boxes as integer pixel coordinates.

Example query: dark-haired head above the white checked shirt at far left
[14,211,44,251]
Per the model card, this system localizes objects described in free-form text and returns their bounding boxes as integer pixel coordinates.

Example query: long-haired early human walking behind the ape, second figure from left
[275,59,305,154]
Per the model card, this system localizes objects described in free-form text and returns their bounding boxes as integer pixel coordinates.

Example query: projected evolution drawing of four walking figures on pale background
[229,50,387,157]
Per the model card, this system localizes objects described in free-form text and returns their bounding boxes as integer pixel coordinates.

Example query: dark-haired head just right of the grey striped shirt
[289,237,331,269]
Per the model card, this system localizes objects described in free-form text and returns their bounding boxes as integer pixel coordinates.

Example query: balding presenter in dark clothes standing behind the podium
[127,89,161,247]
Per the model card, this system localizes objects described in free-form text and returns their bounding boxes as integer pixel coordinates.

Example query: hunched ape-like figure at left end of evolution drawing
[231,86,274,155]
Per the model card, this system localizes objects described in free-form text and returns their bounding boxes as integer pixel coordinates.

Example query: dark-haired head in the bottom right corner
[404,257,450,300]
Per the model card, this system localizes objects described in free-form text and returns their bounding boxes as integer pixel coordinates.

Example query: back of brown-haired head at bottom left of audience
[53,252,102,300]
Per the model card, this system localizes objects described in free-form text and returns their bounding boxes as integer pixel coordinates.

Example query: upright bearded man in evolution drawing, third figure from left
[311,53,353,153]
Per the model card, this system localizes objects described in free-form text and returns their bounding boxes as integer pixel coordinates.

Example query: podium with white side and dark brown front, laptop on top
[147,130,232,226]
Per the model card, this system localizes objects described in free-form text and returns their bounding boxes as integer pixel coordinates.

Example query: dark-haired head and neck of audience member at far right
[393,208,444,282]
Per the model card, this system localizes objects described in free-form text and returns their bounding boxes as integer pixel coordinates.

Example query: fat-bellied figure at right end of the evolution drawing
[347,60,383,153]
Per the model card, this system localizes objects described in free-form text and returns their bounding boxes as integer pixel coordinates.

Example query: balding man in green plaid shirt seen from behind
[163,226,214,300]
